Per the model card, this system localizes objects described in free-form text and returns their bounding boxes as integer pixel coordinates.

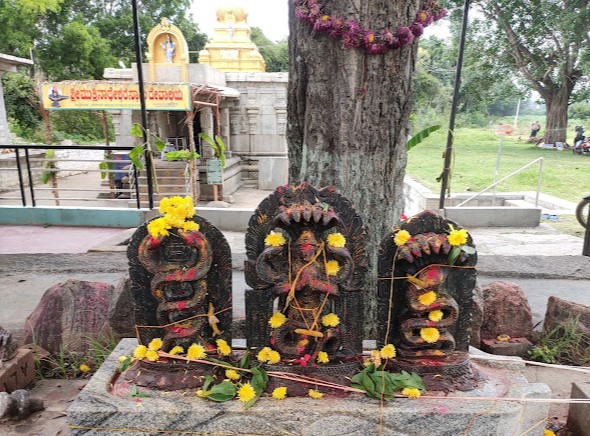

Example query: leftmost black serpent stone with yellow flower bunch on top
[127,197,232,351]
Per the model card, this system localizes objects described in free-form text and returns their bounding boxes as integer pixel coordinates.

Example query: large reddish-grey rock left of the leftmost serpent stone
[25,280,115,353]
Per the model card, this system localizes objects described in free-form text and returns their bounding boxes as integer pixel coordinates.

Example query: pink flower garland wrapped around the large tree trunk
[293,0,447,54]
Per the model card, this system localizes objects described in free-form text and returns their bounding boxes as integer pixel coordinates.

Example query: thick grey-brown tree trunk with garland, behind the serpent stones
[287,0,421,337]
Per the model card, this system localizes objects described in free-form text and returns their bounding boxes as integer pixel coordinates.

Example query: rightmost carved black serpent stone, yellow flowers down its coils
[378,211,477,390]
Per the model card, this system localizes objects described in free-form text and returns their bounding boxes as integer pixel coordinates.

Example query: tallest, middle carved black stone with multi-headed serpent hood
[245,183,366,372]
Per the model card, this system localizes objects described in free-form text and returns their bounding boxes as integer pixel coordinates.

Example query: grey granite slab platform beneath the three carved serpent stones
[68,339,551,436]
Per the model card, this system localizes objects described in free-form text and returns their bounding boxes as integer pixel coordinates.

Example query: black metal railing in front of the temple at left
[0,144,141,209]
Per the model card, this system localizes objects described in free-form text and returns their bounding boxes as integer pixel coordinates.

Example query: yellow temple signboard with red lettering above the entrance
[41,81,191,111]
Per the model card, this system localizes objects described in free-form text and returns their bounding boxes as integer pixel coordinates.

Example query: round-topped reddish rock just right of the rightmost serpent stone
[480,282,533,341]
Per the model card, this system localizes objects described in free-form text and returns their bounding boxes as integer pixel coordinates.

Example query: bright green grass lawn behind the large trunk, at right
[406,127,590,202]
